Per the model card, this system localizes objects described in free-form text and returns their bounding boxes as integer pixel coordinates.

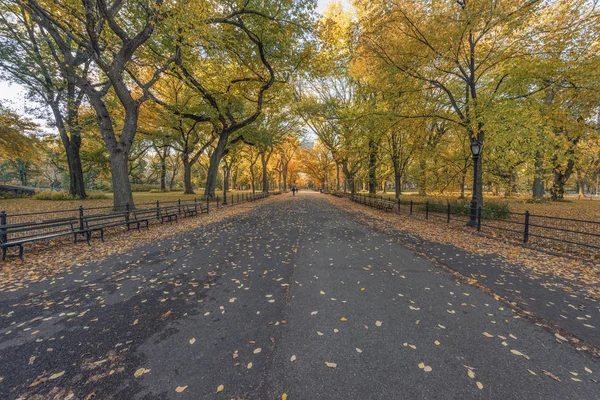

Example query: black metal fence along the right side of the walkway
[334,193,600,256]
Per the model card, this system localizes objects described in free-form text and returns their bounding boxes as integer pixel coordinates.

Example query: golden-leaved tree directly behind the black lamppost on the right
[358,0,542,204]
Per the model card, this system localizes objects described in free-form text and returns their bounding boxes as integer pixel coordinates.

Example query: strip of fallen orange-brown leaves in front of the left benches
[0,197,280,292]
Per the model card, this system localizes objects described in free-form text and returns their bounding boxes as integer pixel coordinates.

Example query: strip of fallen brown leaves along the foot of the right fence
[328,196,600,298]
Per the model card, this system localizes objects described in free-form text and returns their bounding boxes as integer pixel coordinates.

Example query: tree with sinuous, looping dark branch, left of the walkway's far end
[155,0,312,197]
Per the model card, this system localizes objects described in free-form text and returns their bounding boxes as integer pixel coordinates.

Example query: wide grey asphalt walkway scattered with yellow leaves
[0,192,600,400]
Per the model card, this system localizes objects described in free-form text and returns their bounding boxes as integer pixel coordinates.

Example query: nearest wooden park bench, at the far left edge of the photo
[0,217,91,261]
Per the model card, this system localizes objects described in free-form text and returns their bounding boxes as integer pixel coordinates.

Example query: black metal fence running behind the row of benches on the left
[0,193,268,248]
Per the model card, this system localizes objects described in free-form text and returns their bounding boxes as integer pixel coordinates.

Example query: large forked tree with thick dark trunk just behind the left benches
[16,0,175,208]
